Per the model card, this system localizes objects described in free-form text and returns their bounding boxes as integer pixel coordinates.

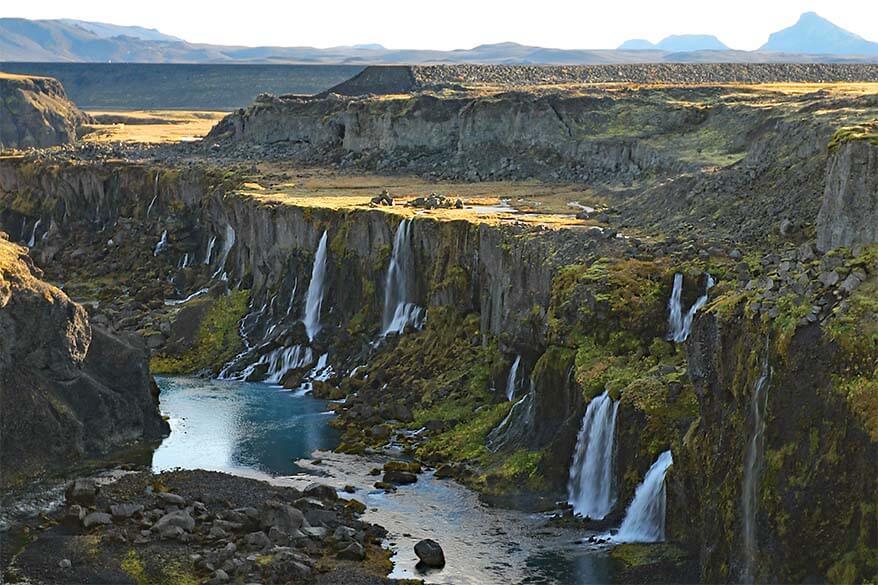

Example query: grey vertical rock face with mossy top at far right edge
[817,136,878,251]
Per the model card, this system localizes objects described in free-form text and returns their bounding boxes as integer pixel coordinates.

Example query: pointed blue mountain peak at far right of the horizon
[759,12,878,55]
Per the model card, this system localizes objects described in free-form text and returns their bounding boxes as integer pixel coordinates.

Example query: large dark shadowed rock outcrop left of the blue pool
[0,234,167,484]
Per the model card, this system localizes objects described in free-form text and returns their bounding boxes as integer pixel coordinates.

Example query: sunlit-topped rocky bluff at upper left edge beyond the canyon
[0,72,90,148]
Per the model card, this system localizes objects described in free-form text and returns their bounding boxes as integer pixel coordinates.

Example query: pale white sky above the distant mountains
[0,0,878,50]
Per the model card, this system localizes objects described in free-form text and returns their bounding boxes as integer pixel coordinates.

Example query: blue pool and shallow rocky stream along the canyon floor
[153,377,612,585]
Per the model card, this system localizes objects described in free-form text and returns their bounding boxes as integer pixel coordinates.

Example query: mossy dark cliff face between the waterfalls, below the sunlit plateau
[0,158,878,582]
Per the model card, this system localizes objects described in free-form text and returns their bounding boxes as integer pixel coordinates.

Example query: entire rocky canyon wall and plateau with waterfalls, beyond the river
[0,66,878,583]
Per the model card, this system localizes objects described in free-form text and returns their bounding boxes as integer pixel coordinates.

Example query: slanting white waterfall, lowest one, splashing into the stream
[615,451,674,542]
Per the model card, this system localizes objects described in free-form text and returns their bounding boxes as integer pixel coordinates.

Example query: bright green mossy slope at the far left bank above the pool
[149,290,250,374]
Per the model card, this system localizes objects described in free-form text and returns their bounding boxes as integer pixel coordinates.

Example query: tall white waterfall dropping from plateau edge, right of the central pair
[382,219,424,335]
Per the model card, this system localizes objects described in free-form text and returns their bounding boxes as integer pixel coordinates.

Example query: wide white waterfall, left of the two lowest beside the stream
[567,392,619,520]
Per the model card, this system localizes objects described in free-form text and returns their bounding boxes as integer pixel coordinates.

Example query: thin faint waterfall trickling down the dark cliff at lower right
[741,339,770,583]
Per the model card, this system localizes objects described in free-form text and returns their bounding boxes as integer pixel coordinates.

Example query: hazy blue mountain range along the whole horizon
[0,12,878,65]
